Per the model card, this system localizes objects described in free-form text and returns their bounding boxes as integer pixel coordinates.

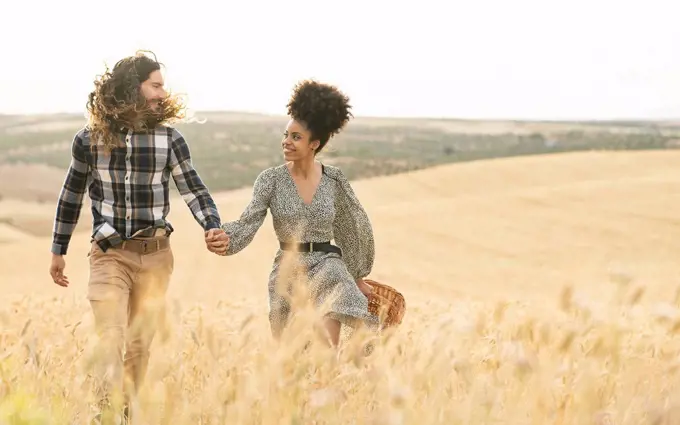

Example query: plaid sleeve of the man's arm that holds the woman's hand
[170,129,221,231]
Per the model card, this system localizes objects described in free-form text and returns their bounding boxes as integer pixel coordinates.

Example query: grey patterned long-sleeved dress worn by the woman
[222,164,378,334]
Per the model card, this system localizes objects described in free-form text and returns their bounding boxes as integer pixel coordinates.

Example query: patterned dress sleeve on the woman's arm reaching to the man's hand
[221,169,275,255]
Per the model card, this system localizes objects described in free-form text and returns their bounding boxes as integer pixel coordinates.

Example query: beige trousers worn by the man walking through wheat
[87,237,174,407]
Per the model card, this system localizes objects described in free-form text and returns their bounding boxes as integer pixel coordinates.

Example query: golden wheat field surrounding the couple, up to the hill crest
[0,151,680,425]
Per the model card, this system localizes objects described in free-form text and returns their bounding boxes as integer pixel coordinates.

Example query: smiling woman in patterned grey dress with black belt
[211,80,378,346]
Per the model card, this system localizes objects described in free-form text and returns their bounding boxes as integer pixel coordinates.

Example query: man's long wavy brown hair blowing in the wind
[87,51,185,152]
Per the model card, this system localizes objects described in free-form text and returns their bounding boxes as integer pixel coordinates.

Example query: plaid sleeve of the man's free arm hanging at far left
[51,133,89,255]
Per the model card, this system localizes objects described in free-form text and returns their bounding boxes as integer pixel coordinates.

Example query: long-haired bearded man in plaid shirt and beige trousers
[50,52,227,423]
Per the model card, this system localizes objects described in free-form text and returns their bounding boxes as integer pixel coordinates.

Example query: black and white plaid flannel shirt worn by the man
[52,126,220,255]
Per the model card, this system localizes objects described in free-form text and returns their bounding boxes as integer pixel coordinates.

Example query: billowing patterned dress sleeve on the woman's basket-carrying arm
[329,167,375,280]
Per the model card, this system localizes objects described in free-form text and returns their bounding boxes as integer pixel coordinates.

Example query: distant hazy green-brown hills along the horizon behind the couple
[0,112,680,202]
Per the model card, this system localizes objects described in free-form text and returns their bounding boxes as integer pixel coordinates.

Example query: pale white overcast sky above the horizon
[0,0,680,119]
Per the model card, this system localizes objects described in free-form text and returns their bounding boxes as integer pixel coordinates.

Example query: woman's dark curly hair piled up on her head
[286,80,353,153]
